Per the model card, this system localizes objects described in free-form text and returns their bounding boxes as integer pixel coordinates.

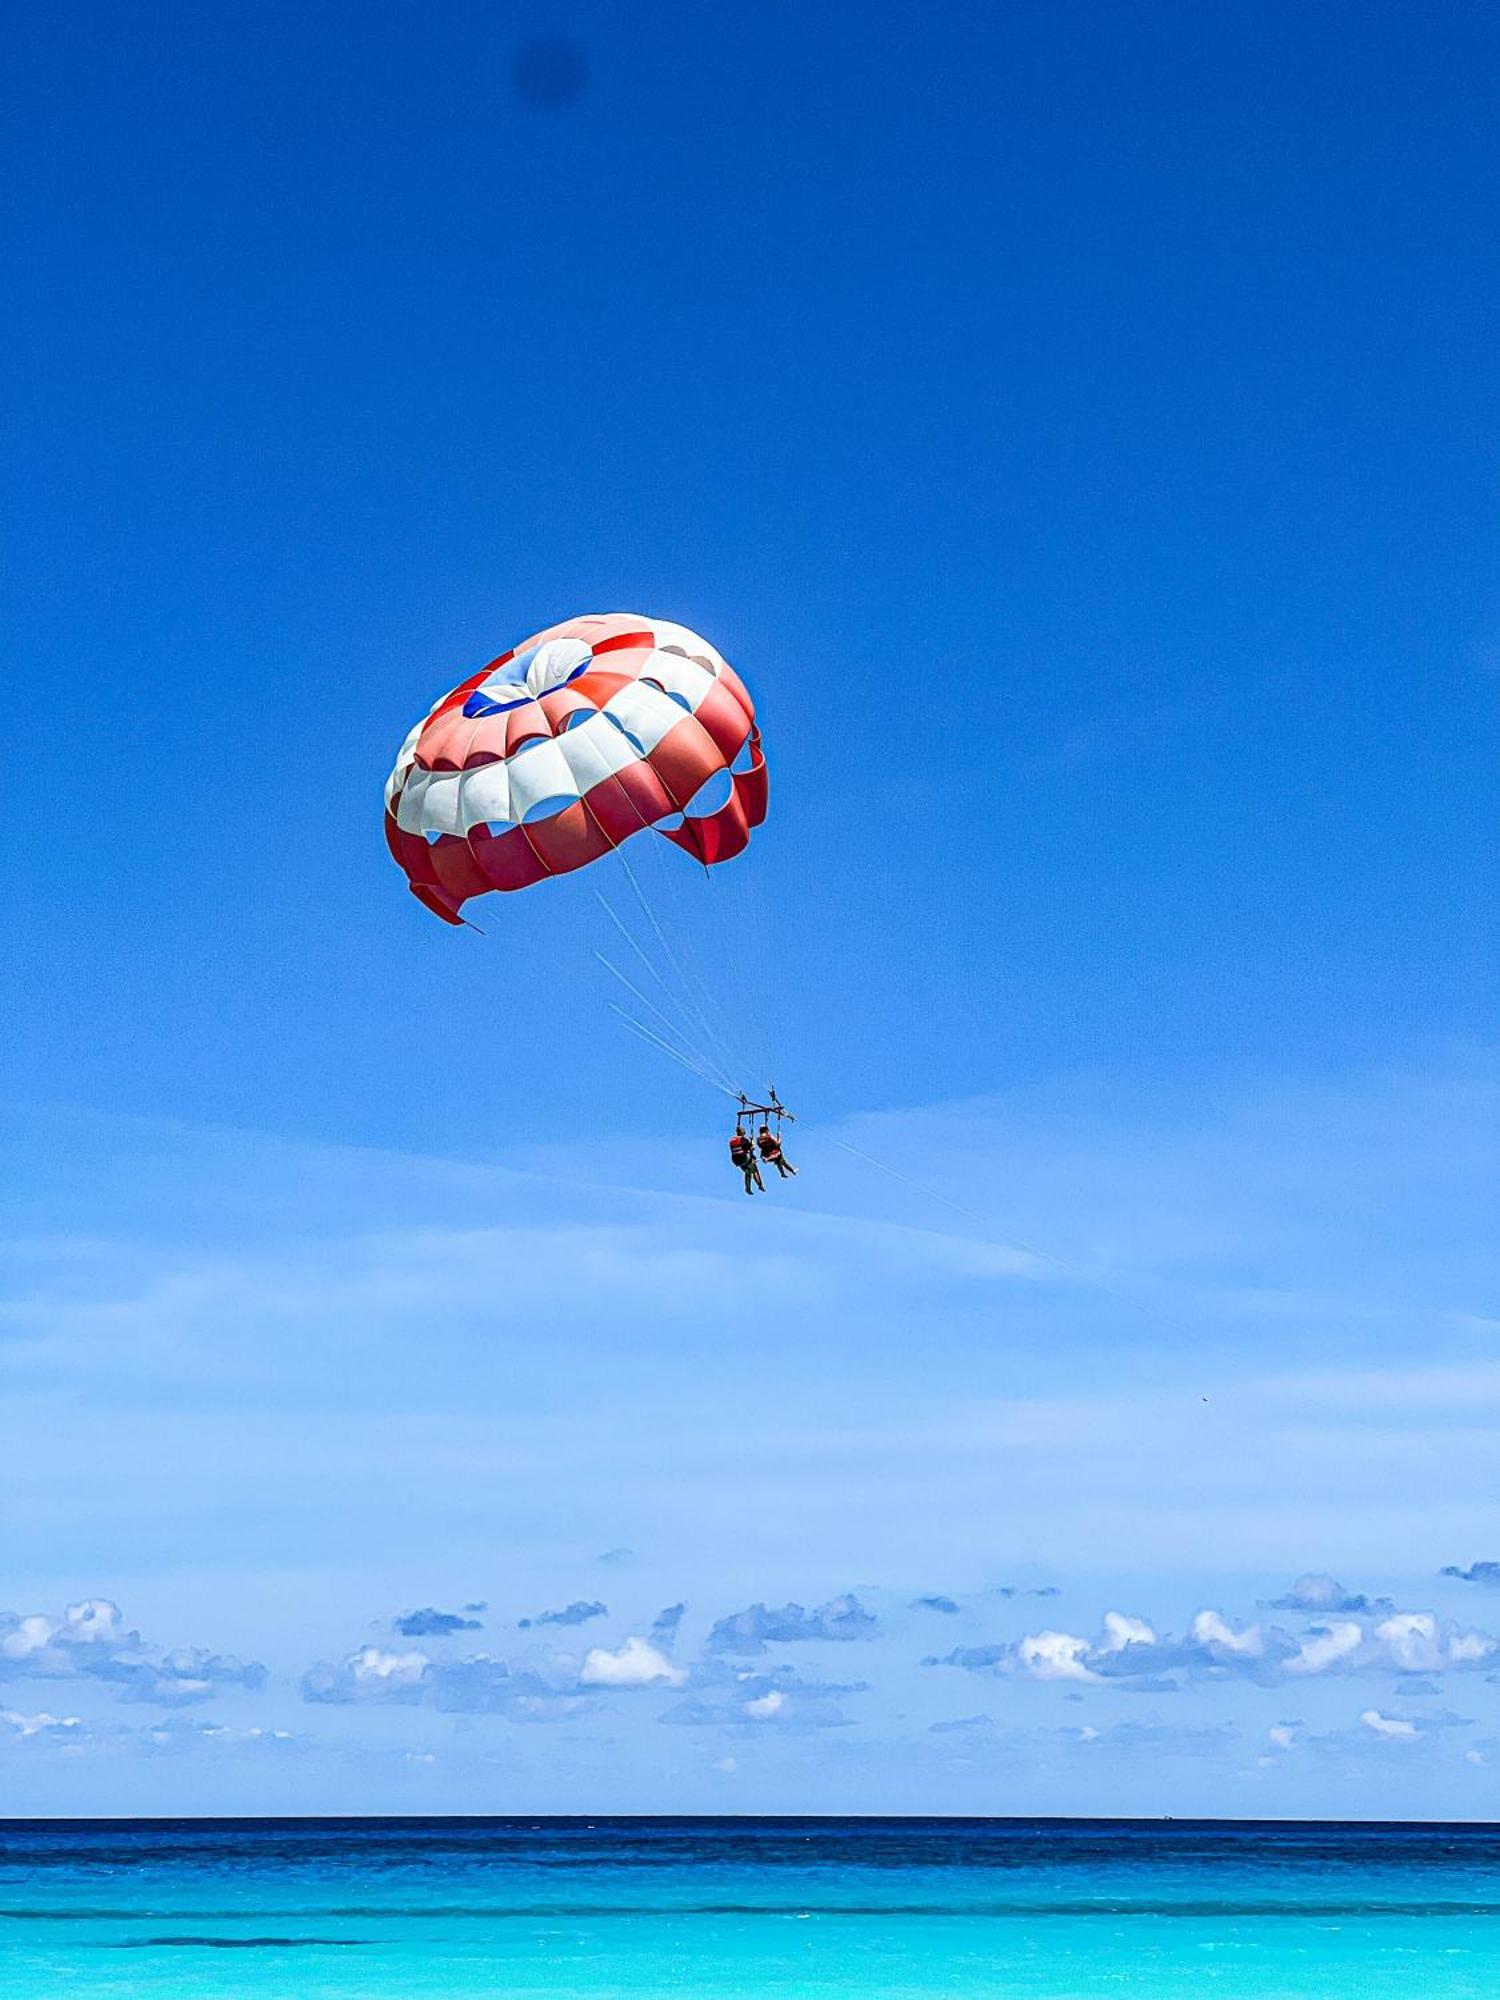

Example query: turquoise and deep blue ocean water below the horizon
[0,1820,1500,2000]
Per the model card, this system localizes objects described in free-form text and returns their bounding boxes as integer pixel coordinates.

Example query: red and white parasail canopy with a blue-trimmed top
[386,612,768,924]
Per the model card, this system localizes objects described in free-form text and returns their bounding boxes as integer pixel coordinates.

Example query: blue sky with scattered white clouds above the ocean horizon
[0,6,1500,1816]
